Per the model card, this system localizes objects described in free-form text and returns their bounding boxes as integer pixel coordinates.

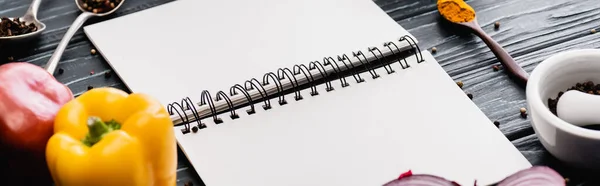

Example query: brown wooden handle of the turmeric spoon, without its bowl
[469,23,529,85]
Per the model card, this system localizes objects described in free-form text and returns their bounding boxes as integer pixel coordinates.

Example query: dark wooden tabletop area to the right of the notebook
[390,0,600,185]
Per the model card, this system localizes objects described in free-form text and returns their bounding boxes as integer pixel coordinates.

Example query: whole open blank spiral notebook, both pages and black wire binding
[85,0,531,186]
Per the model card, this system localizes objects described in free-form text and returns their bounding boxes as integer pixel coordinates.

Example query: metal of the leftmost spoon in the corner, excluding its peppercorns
[0,0,46,42]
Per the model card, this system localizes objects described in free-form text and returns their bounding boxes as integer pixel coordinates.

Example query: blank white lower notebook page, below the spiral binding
[176,51,531,186]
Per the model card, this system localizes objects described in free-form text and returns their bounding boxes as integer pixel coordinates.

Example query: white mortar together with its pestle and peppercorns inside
[526,49,600,170]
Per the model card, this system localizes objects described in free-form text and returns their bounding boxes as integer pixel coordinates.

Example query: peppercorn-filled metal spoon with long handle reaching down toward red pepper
[45,0,125,74]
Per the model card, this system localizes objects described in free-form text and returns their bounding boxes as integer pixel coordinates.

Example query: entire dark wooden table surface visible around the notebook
[0,0,600,185]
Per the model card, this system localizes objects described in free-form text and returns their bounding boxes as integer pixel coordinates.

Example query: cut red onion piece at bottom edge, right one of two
[497,166,566,186]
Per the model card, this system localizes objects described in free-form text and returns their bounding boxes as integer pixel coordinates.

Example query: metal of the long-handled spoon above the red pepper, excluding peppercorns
[46,0,125,74]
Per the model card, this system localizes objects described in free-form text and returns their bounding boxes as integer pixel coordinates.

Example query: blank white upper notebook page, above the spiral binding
[85,0,410,105]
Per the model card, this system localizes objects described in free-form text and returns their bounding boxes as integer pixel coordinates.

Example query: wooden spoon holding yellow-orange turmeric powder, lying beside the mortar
[437,0,529,85]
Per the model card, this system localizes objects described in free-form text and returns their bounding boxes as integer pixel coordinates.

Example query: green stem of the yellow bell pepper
[82,116,120,147]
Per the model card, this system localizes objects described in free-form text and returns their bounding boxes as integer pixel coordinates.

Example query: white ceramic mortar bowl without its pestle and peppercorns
[526,49,600,169]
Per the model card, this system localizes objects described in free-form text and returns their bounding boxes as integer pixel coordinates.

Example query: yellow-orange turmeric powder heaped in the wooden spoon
[437,0,475,23]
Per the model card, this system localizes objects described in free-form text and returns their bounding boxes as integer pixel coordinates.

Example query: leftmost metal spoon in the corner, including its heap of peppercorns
[0,0,46,43]
